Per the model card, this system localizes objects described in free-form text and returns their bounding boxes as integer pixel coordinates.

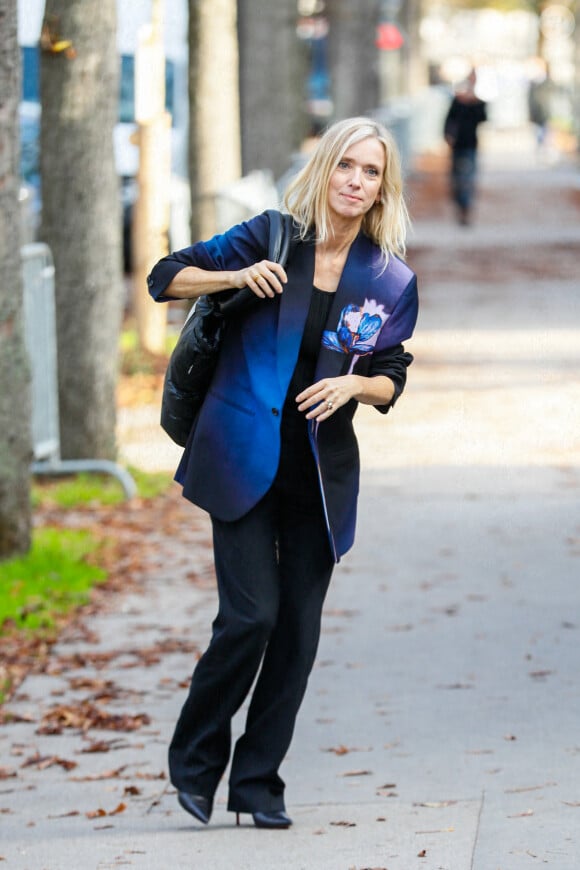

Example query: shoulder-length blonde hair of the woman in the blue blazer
[284,118,409,261]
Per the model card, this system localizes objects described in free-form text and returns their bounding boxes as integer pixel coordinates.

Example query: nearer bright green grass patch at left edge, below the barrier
[0,528,107,633]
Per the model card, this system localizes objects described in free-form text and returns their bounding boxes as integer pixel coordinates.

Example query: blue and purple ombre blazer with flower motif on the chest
[147,214,418,561]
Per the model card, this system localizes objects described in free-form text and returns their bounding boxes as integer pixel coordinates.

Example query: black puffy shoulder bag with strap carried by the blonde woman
[161,209,292,447]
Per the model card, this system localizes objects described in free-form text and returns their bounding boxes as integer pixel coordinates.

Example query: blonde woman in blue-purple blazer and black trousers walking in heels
[148,118,417,828]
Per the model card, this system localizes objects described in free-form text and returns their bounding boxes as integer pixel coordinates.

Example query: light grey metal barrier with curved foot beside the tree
[21,242,137,498]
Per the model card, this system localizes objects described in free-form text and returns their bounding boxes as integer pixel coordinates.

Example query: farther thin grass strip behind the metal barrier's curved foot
[32,468,172,510]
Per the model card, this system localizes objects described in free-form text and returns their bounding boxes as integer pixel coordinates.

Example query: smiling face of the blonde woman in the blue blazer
[328,136,385,221]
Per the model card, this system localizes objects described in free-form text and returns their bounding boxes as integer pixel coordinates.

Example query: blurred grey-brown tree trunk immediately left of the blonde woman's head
[238,0,308,178]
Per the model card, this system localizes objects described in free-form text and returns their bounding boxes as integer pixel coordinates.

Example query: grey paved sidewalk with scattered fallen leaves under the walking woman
[0,133,580,870]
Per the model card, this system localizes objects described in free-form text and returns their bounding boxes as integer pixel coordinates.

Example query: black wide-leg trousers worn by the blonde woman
[169,481,334,812]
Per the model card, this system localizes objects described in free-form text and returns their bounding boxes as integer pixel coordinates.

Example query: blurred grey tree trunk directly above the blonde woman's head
[327,0,379,120]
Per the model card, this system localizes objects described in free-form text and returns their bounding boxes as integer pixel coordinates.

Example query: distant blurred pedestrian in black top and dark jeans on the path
[443,70,487,226]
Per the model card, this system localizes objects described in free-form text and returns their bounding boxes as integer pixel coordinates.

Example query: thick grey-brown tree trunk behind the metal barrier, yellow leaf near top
[40,0,124,459]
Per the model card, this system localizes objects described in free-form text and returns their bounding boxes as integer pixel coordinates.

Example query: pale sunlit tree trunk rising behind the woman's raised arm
[189,0,241,241]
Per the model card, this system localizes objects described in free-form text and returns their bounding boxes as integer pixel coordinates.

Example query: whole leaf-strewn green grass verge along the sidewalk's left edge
[0,468,171,700]
